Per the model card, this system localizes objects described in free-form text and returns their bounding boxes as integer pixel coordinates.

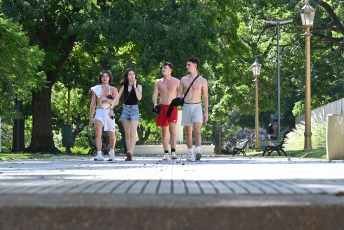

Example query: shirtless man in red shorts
[152,62,179,160]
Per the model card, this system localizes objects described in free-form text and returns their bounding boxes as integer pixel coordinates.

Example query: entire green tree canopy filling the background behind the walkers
[0,0,344,151]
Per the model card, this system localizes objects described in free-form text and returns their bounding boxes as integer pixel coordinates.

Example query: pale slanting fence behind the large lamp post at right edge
[295,98,344,124]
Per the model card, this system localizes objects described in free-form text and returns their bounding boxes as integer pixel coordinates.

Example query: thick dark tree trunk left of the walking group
[27,86,59,153]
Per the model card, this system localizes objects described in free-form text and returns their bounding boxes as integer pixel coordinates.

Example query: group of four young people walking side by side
[90,57,208,161]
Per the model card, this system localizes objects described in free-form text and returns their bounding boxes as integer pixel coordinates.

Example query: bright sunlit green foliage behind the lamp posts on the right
[213,0,344,126]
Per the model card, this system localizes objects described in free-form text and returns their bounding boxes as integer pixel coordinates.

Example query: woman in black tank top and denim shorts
[114,68,142,161]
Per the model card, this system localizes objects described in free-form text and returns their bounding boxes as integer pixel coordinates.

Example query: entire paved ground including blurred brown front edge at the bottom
[0,156,344,230]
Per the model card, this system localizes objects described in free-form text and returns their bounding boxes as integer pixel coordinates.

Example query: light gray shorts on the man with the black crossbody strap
[182,104,203,126]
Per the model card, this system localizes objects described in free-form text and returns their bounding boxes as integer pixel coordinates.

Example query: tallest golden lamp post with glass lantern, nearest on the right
[300,0,315,151]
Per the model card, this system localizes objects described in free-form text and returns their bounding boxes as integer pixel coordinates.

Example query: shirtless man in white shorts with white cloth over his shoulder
[90,70,118,161]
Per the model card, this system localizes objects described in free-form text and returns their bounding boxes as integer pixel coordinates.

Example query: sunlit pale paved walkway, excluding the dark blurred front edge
[0,156,344,195]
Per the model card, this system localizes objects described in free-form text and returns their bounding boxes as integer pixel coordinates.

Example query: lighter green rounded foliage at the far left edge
[0,14,45,117]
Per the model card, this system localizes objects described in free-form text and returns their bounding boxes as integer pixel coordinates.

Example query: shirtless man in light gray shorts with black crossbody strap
[177,57,208,161]
